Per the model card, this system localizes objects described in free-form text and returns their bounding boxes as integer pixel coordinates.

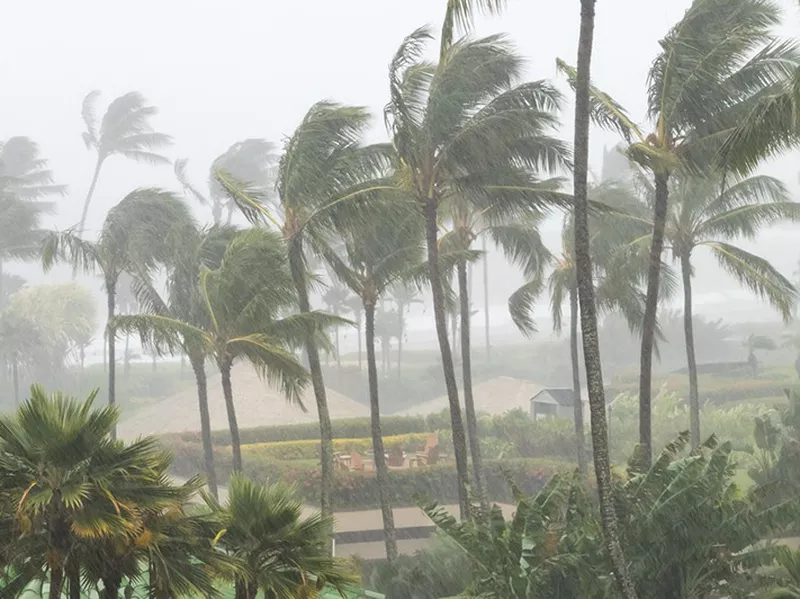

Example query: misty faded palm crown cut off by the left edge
[0,137,67,296]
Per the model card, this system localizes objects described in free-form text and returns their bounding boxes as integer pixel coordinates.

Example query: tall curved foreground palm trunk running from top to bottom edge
[573,0,636,599]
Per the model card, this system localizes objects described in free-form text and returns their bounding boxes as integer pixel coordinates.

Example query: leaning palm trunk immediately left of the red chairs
[289,241,334,517]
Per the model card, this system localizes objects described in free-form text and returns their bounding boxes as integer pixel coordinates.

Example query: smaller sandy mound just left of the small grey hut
[397,376,545,416]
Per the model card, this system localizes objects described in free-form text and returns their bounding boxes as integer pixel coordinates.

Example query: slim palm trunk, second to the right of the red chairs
[458,262,489,507]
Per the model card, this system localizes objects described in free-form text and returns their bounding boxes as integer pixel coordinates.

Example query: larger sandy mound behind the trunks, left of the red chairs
[119,365,369,439]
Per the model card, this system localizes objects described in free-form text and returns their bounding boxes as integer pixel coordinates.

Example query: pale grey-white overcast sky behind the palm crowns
[0,0,800,328]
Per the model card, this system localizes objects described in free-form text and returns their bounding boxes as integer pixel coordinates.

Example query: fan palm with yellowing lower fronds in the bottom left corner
[0,386,180,599]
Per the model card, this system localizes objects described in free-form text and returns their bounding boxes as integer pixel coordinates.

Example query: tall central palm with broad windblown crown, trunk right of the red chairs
[386,24,564,515]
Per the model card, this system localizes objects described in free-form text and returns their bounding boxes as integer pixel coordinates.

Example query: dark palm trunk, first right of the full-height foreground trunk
[639,173,669,469]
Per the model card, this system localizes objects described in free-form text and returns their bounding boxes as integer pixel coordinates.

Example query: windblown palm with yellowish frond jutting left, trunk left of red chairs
[216,101,391,516]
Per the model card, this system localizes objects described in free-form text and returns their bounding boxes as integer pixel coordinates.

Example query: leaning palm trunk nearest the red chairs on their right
[425,198,469,519]
